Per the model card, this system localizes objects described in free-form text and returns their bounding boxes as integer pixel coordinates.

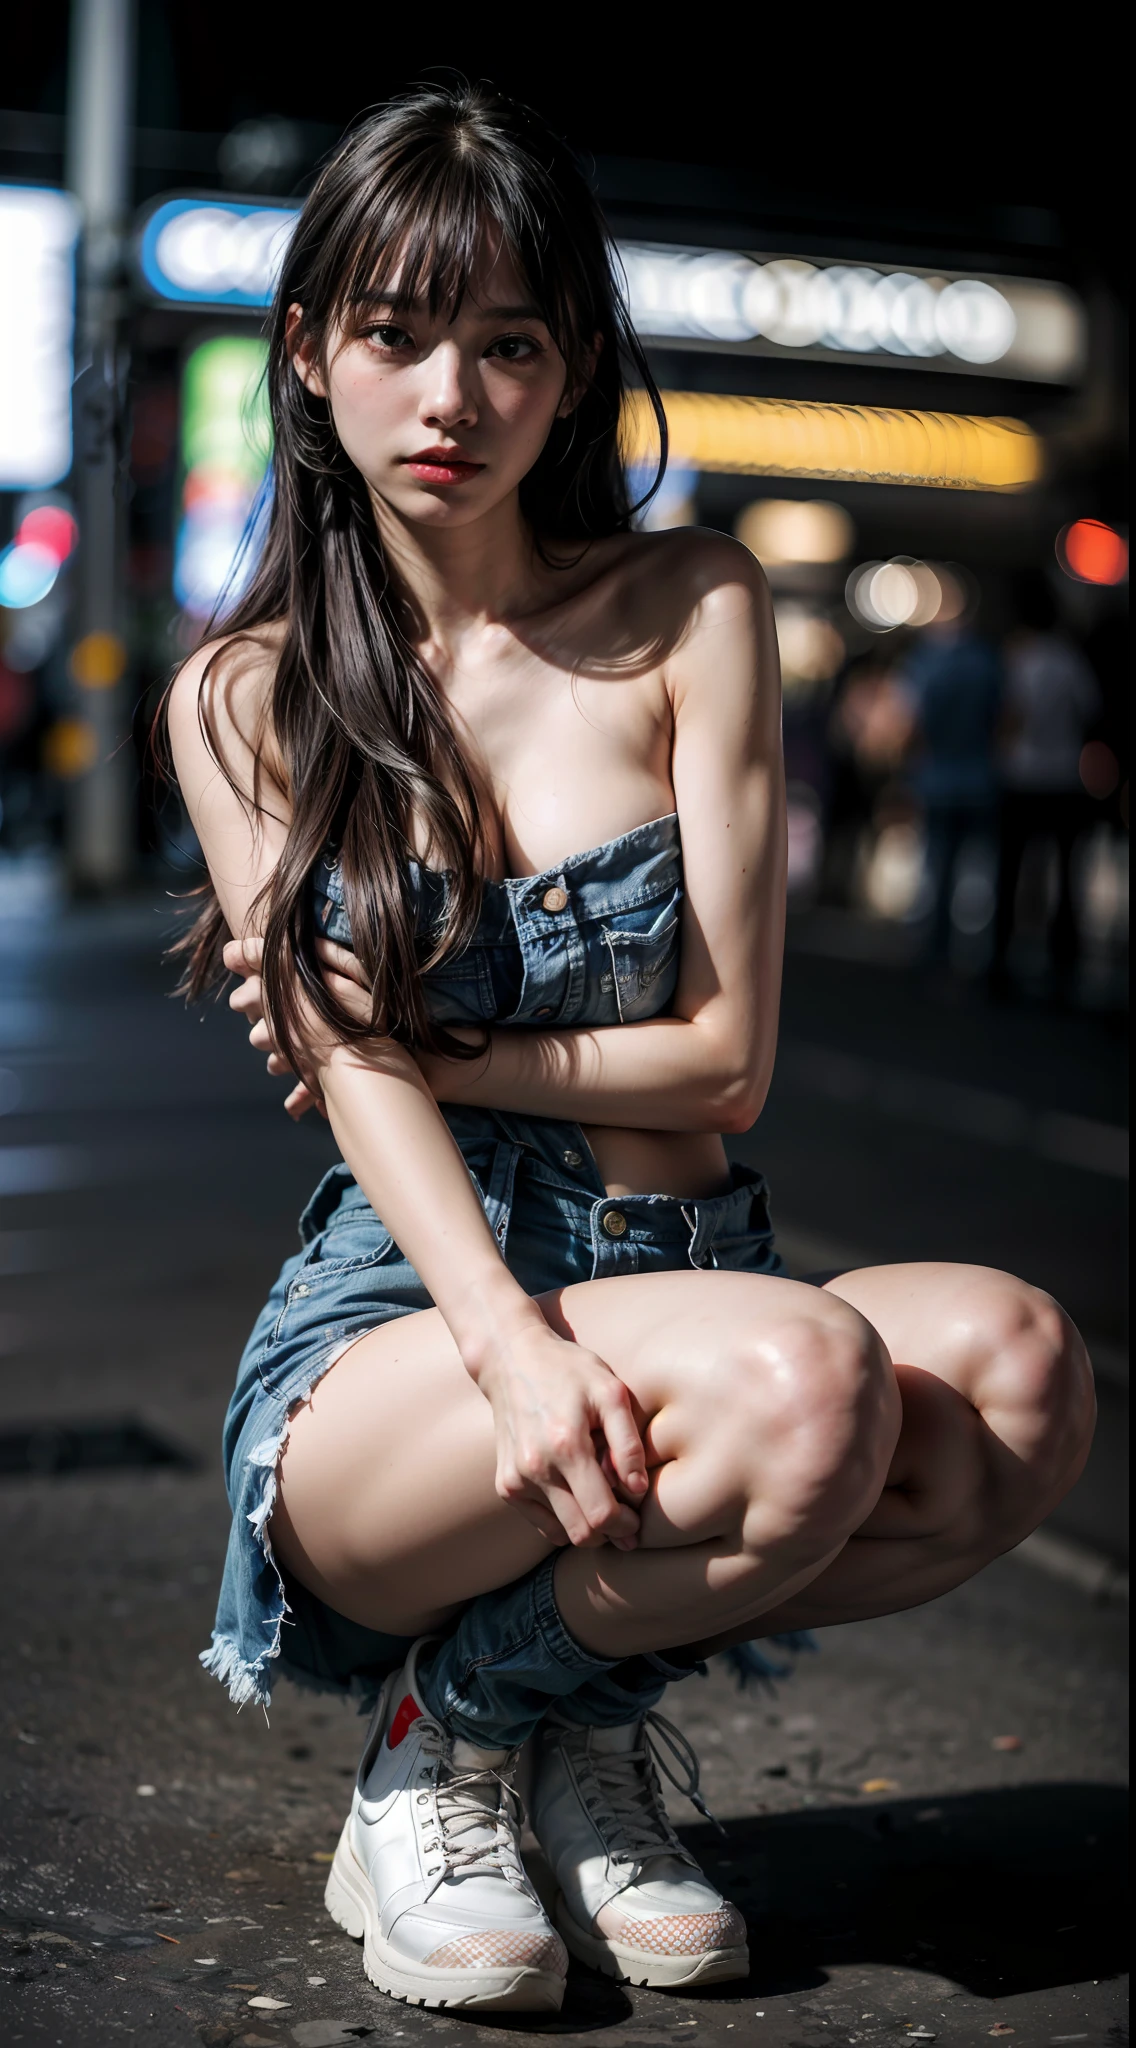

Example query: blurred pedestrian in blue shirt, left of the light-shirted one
[899,618,1003,963]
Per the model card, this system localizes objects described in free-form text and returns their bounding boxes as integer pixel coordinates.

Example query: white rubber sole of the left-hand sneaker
[323,1815,565,2013]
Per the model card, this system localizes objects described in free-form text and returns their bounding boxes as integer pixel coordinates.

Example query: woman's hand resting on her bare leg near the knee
[475,1319,649,1550]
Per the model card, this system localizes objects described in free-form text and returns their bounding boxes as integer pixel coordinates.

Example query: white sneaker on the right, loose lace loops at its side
[530,1714,749,1987]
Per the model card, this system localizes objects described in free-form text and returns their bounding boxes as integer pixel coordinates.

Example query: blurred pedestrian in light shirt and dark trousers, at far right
[991,575,1101,999]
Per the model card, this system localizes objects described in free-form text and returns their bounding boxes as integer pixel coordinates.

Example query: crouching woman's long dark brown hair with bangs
[166,84,665,1057]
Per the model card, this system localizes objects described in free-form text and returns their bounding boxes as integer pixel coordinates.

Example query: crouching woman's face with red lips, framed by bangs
[289,244,571,528]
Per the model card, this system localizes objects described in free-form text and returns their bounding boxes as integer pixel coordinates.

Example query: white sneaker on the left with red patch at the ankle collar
[323,1638,567,2013]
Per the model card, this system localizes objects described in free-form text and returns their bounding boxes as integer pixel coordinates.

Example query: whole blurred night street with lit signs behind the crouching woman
[0,16,1130,2048]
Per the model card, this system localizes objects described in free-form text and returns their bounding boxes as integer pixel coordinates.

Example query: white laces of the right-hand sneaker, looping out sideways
[569,1712,725,1864]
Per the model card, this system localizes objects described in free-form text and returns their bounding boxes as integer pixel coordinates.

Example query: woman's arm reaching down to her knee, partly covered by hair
[170,630,647,1546]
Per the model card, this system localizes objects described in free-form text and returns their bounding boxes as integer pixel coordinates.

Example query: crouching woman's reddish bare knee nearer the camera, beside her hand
[704,1290,901,1544]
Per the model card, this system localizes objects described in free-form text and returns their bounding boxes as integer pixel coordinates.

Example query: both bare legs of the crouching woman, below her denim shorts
[272,1264,1095,1657]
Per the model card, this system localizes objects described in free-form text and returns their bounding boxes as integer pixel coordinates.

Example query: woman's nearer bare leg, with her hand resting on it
[272,1272,899,1661]
